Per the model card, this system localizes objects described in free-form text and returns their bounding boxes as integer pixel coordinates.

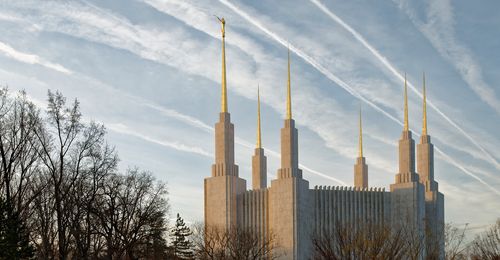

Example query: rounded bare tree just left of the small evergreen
[94,169,168,259]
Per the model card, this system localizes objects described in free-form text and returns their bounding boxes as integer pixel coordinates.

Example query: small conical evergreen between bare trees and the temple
[170,213,193,259]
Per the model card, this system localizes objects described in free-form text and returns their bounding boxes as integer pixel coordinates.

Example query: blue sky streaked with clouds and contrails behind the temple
[0,0,500,234]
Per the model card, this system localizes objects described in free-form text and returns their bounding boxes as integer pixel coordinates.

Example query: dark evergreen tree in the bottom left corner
[0,197,35,260]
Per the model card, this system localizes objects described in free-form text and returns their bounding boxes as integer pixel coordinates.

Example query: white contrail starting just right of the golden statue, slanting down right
[219,0,500,195]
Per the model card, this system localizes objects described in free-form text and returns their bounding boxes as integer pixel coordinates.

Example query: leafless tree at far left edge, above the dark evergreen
[0,88,40,219]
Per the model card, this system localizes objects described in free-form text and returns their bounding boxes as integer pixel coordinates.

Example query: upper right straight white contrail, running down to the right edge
[310,0,500,169]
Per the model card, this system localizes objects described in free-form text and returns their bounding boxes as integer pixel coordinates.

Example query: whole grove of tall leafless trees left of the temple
[0,88,168,260]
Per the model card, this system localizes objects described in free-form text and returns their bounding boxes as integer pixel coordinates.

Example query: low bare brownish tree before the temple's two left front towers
[193,223,279,260]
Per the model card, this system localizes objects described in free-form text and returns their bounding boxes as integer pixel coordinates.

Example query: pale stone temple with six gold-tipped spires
[204,19,444,259]
